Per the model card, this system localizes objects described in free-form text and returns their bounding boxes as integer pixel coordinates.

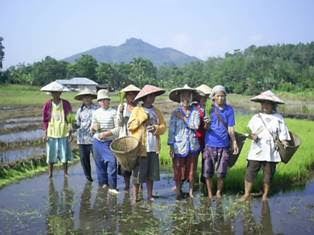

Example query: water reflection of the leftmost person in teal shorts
[47,177,74,234]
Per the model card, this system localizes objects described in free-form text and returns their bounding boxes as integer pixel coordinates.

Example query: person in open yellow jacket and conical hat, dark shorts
[128,85,166,201]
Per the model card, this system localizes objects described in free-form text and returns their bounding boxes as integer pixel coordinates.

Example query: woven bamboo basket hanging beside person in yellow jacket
[110,136,139,171]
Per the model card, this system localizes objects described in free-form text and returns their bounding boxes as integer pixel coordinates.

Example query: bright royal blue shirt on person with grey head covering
[205,105,235,148]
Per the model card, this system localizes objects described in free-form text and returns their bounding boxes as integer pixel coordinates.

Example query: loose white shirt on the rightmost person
[247,113,290,162]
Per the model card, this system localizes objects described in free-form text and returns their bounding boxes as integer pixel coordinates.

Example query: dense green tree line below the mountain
[0,42,314,95]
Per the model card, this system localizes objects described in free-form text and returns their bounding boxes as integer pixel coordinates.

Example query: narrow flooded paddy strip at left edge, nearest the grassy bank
[0,147,46,165]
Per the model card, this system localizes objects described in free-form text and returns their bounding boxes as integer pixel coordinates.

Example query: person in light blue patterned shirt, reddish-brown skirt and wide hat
[168,85,200,200]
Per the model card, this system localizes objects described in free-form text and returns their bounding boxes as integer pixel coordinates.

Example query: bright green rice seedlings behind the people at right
[160,115,314,193]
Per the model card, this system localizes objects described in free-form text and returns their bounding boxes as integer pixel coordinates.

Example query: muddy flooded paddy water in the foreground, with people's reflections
[0,164,314,234]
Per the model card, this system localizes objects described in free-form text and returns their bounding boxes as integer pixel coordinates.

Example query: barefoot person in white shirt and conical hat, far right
[241,90,290,201]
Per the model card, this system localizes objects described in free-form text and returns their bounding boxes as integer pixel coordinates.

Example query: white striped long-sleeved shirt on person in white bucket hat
[92,108,119,141]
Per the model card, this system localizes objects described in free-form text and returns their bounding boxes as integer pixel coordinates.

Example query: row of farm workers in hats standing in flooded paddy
[41,82,290,201]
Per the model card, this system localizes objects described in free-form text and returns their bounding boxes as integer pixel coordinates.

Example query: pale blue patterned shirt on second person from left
[75,104,99,144]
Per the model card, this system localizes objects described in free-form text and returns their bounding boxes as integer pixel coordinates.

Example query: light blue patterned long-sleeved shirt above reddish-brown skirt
[168,107,200,157]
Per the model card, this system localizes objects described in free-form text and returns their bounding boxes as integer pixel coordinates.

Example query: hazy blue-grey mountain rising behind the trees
[63,38,200,66]
